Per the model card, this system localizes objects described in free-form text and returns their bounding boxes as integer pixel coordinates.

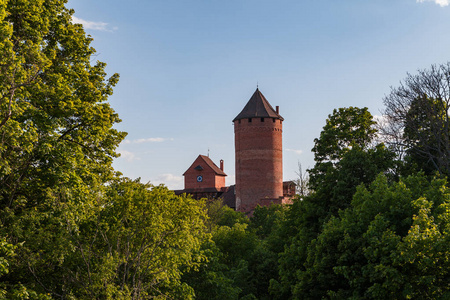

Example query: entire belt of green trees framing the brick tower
[0,0,450,300]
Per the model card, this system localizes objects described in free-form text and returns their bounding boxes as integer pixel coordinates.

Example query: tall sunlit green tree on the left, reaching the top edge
[0,0,125,202]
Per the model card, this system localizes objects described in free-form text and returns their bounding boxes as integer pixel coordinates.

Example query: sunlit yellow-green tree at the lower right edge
[394,197,450,299]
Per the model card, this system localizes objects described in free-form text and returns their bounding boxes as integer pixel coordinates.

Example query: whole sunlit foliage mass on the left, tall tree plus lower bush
[0,0,214,299]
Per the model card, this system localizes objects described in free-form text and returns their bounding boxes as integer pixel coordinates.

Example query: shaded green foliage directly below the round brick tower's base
[183,201,286,299]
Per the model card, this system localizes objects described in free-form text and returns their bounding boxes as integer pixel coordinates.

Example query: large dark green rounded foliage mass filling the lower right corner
[293,175,450,299]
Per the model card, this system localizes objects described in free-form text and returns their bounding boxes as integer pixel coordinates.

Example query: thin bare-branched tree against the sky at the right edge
[381,62,450,176]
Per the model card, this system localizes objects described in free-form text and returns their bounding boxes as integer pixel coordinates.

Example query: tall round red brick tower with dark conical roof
[233,88,284,212]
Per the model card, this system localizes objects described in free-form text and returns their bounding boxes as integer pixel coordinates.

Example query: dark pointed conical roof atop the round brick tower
[233,88,284,122]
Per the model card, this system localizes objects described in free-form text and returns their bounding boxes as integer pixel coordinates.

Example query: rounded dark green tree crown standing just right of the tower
[308,107,394,221]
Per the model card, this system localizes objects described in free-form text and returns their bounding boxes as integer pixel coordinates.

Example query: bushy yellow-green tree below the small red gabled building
[92,179,209,299]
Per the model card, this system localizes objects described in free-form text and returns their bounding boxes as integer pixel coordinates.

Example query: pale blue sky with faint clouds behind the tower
[67,0,450,189]
